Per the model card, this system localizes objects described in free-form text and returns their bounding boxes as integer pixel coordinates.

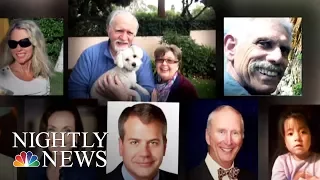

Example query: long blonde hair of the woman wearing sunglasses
[0,20,52,78]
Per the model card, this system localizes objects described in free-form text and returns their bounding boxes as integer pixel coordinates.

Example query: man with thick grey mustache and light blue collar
[224,18,292,96]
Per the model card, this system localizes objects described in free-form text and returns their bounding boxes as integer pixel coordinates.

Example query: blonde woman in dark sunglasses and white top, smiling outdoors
[0,20,51,96]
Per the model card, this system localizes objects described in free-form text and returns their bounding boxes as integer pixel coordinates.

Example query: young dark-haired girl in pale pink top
[271,113,320,180]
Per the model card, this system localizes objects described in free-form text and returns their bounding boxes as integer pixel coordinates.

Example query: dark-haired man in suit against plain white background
[106,103,178,180]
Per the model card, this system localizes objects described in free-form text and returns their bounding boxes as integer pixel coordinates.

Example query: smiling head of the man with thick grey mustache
[225,19,291,95]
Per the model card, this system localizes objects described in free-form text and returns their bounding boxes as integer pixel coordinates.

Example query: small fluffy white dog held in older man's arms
[90,45,150,105]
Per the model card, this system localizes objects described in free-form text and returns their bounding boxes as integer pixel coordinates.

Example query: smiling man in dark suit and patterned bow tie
[188,105,257,180]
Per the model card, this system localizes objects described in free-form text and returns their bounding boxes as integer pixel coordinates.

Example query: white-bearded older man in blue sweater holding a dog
[68,10,155,101]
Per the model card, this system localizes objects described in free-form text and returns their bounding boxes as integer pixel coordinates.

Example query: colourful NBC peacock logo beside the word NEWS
[13,151,40,167]
